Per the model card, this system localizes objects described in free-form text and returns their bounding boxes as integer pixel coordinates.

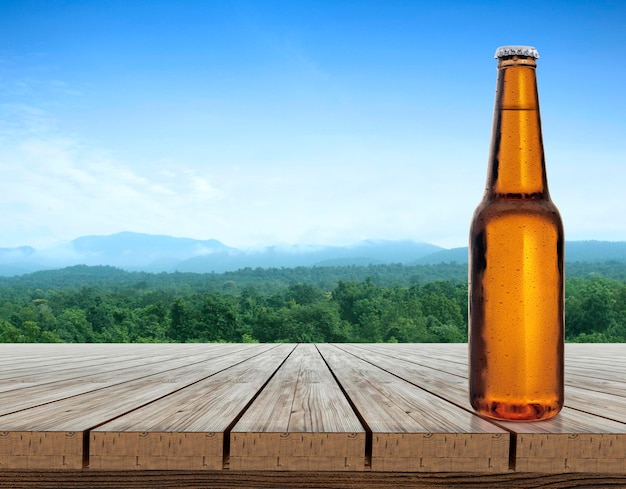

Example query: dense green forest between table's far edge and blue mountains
[0,262,626,343]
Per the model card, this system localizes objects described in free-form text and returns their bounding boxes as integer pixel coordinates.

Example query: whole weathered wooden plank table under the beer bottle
[0,344,626,488]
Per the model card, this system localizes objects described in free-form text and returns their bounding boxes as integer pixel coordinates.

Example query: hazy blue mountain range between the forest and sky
[0,232,626,276]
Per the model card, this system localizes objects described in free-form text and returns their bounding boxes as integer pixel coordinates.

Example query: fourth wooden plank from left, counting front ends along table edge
[318,345,509,472]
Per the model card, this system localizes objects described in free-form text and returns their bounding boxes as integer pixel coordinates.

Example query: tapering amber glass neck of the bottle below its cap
[487,56,548,199]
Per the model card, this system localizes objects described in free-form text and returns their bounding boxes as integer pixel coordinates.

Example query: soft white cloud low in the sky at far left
[0,133,227,246]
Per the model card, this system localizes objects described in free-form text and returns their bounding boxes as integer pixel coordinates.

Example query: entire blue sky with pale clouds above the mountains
[0,0,626,248]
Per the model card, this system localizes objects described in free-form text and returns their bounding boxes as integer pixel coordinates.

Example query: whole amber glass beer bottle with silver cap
[469,46,564,421]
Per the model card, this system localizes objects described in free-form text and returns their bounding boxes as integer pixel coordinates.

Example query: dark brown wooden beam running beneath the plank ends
[0,470,626,489]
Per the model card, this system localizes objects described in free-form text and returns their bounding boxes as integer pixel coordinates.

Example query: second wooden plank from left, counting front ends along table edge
[89,345,294,470]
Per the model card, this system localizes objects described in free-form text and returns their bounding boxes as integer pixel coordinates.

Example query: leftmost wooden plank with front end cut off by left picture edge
[0,345,273,469]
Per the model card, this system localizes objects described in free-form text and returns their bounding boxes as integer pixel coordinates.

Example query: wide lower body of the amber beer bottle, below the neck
[470,201,563,421]
